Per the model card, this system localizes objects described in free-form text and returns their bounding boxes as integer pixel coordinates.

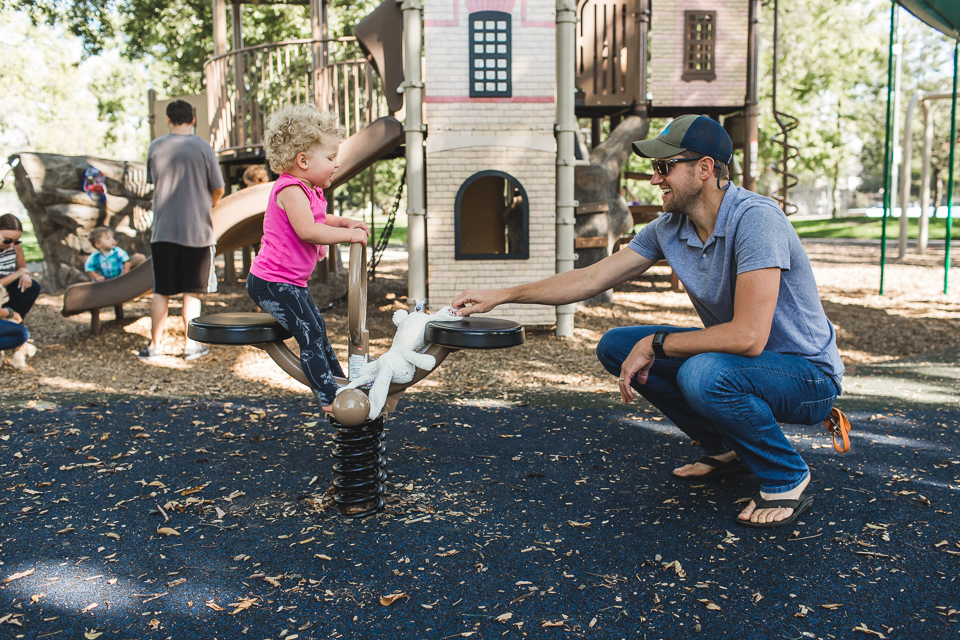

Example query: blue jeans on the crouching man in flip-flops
[597,326,839,493]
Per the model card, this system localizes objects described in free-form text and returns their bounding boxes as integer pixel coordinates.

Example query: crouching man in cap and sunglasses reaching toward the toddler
[453,115,845,528]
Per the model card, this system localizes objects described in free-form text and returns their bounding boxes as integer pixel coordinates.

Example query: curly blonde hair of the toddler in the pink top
[263,104,345,174]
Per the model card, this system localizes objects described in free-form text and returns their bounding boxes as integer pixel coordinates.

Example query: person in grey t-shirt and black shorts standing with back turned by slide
[139,100,223,360]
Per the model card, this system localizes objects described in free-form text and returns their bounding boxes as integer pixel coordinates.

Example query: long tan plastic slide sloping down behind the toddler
[60,116,403,335]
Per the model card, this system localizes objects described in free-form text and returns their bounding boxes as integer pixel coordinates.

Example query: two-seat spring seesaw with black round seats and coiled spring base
[187,244,524,518]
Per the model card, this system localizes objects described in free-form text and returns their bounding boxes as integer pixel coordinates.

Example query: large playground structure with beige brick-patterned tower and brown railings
[169,0,760,335]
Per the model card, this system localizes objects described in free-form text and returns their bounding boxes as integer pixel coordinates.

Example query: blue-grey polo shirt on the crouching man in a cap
[630,185,843,385]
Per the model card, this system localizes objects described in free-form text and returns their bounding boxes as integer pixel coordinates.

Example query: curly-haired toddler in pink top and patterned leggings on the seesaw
[247,105,369,412]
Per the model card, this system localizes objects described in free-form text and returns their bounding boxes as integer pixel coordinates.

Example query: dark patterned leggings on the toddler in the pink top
[247,273,345,406]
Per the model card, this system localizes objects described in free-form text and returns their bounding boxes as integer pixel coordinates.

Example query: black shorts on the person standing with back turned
[150,242,217,296]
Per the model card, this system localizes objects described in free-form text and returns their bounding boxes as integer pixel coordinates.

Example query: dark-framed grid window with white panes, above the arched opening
[470,11,513,98]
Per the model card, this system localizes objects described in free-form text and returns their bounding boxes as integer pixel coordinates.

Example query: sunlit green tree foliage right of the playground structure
[758,0,953,215]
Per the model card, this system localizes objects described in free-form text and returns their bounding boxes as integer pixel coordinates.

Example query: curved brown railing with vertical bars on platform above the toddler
[204,37,388,155]
